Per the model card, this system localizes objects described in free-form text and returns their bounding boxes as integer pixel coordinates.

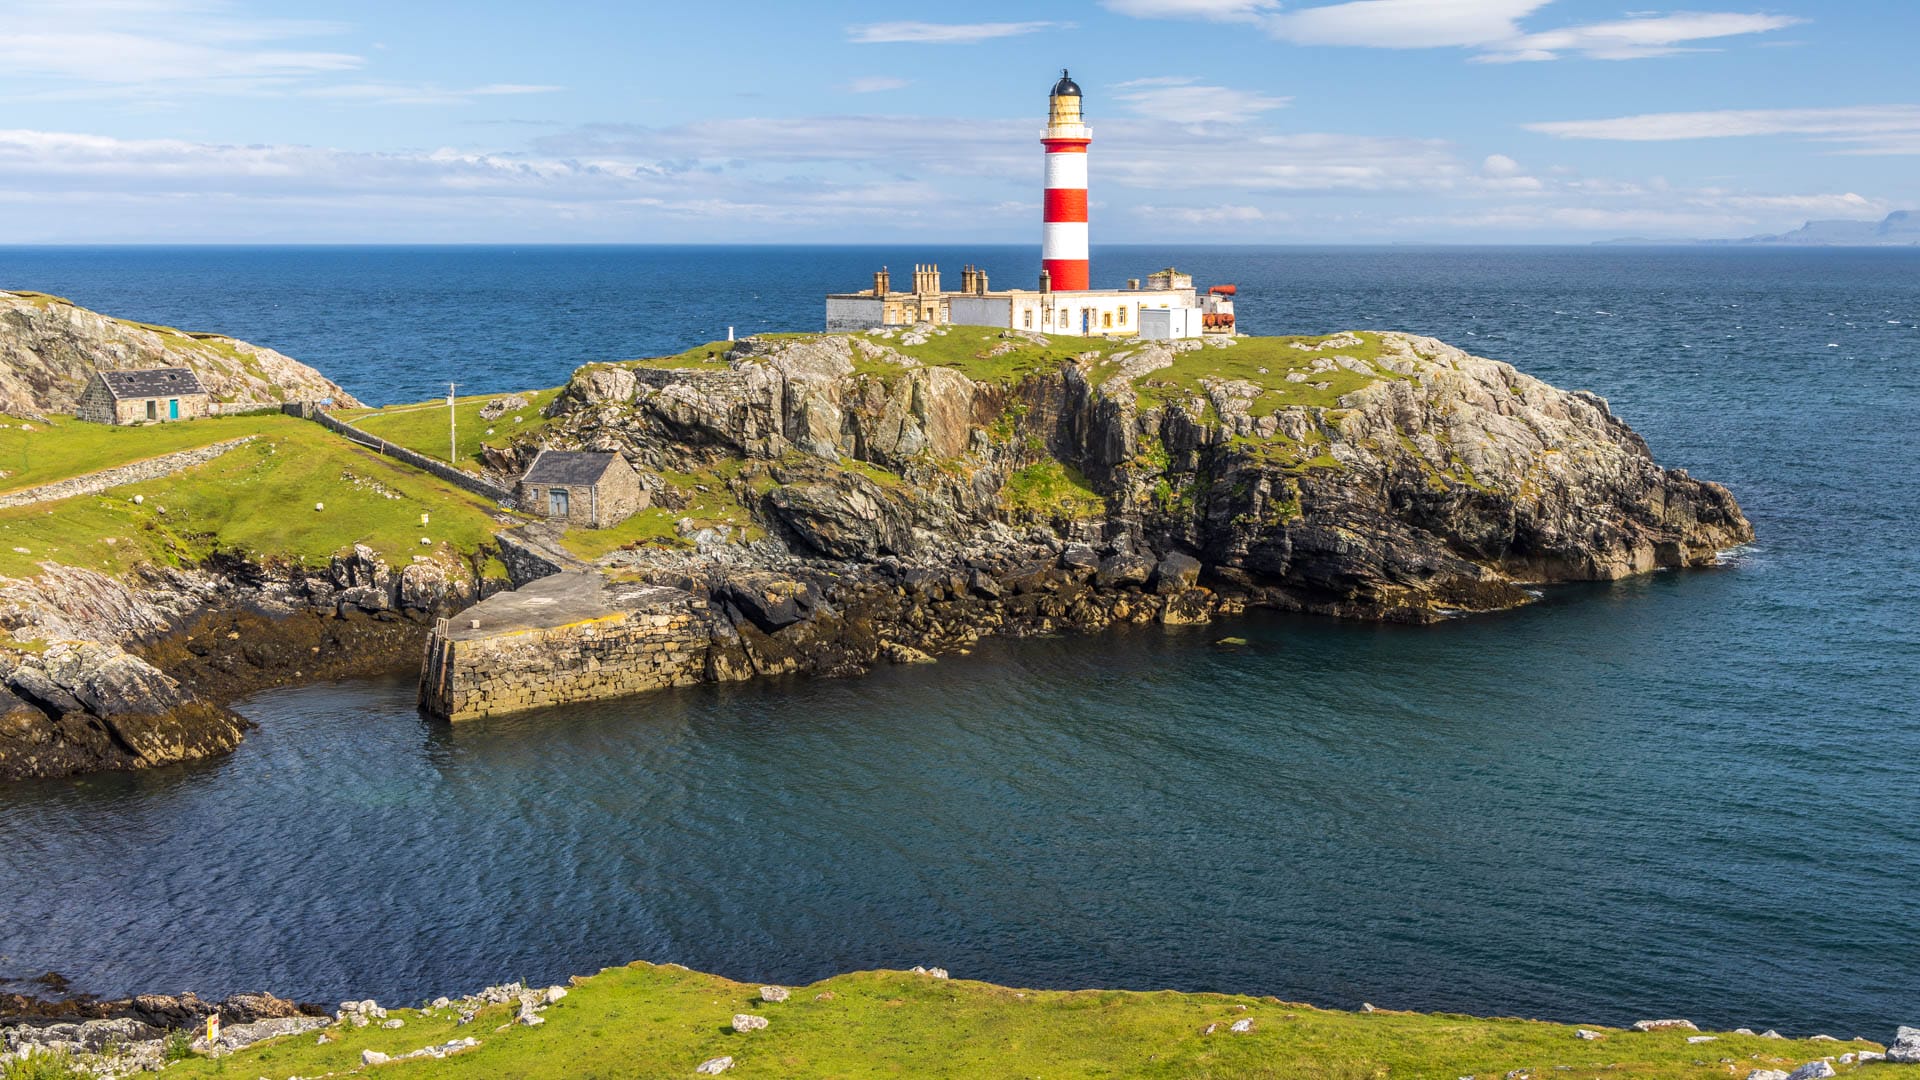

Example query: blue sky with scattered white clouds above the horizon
[0,0,1920,244]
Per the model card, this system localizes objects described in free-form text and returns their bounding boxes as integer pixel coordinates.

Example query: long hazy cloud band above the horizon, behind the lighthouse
[0,99,1887,242]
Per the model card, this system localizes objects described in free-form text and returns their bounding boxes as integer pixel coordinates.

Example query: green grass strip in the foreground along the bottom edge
[167,965,1896,1080]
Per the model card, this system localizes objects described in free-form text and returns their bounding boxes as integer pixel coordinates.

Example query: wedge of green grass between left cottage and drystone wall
[0,413,297,494]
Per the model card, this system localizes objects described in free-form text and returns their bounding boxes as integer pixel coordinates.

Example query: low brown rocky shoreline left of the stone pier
[0,548,488,780]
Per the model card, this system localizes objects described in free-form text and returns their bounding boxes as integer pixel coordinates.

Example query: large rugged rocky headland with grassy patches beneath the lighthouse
[529,327,1753,621]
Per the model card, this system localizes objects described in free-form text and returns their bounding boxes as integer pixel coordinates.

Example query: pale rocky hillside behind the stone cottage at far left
[0,292,359,417]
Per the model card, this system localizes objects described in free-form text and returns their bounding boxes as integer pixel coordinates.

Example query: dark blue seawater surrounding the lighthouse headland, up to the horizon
[0,248,1920,1038]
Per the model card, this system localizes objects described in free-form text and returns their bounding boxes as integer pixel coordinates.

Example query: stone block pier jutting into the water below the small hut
[420,573,714,721]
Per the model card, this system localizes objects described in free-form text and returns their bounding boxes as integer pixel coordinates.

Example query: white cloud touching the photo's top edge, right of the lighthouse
[1106,0,1805,63]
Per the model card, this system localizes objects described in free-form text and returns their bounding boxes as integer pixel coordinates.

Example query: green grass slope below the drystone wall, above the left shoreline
[0,417,514,577]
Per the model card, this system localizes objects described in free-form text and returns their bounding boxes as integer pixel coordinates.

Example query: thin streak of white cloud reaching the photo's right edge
[1524,106,1920,154]
